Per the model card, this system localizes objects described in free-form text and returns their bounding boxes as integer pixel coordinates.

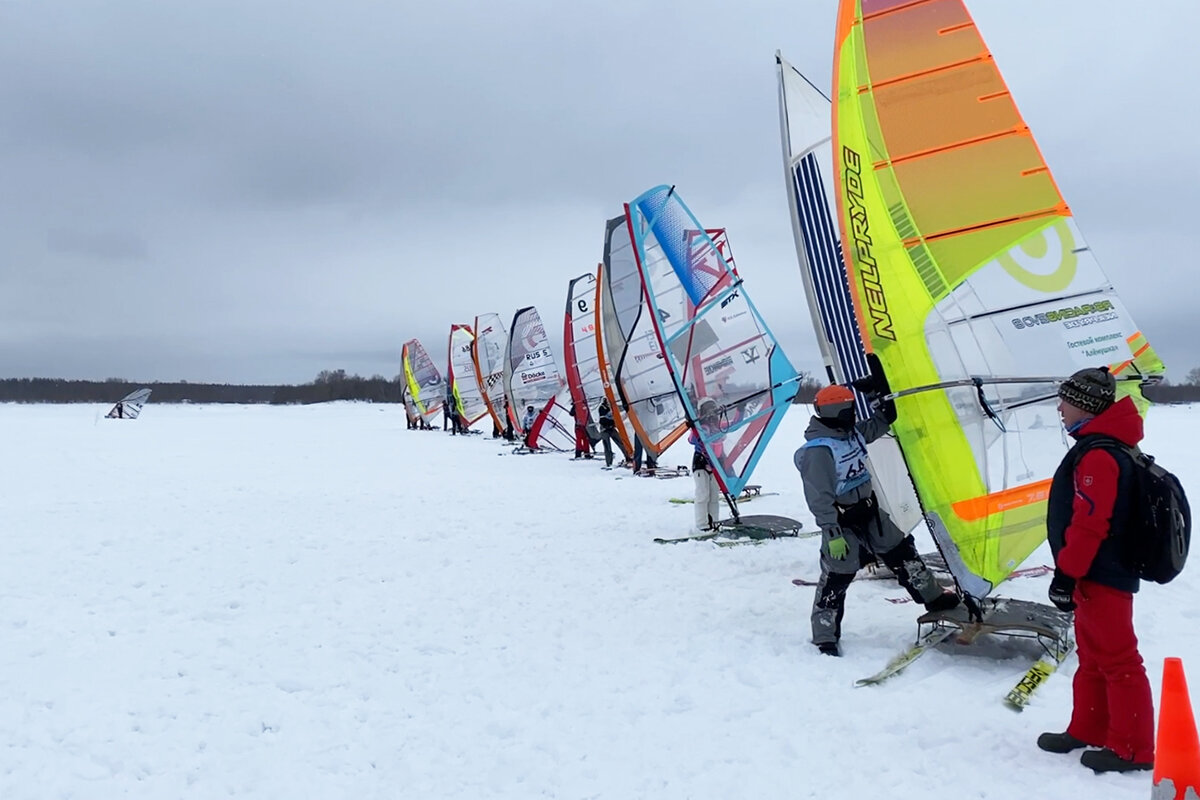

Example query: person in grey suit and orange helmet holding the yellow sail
[794,384,959,656]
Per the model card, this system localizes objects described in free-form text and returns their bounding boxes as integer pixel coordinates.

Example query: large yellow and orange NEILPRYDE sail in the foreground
[833,0,1164,597]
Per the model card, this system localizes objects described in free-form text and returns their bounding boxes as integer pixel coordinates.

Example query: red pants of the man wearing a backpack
[1067,579,1154,763]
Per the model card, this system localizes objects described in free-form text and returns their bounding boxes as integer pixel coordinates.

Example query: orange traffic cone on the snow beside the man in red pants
[1151,658,1200,800]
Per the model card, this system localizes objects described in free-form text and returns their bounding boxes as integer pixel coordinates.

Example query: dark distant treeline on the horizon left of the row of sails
[0,369,401,404]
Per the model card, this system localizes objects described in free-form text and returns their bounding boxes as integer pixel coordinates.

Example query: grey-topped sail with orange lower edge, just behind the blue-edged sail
[604,216,688,456]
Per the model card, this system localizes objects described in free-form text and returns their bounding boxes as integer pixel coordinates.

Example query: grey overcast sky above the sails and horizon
[0,0,1200,383]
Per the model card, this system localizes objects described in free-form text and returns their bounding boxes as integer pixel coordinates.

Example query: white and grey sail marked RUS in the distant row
[505,306,575,450]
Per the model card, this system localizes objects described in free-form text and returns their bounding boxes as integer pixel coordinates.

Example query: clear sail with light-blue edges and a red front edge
[625,186,799,503]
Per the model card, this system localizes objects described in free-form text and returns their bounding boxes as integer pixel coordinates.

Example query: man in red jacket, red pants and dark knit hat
[1038,367,1154,772]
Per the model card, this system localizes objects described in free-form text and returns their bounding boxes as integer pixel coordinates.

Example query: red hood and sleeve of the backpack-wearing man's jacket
[1055,397,1144,578]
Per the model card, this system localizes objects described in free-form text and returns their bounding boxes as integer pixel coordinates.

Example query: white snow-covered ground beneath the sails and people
[0,403,1200,800]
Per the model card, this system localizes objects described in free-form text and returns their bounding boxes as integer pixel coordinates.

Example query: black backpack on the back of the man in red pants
[1075,435,1192,583]
